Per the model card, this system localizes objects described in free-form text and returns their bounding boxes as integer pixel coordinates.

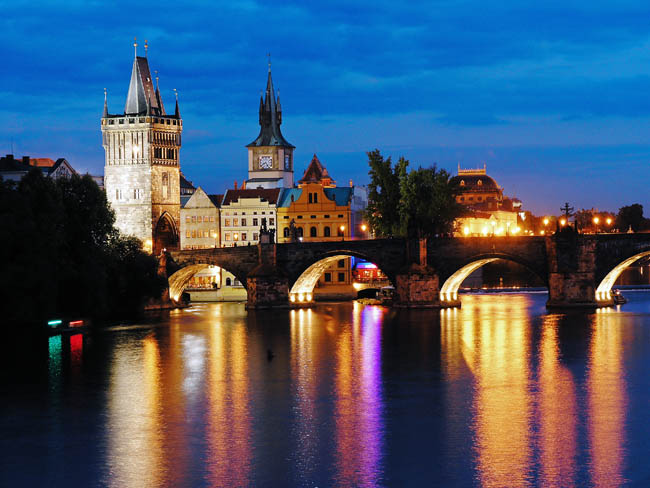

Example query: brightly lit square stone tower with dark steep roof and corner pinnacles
[101,41,183,255]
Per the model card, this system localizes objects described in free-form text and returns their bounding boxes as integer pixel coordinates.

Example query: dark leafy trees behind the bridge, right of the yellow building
[366,149,464,237]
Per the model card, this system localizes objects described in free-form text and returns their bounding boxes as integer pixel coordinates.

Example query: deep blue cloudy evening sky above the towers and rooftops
[0,0,650,214]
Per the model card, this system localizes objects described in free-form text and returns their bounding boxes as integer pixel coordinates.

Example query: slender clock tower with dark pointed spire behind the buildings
[246,62,295,188]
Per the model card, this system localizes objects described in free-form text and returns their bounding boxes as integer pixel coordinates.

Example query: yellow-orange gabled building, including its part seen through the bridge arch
[277,155,355,299]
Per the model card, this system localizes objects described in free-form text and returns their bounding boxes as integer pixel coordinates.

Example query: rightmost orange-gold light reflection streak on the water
[587,314,627,487]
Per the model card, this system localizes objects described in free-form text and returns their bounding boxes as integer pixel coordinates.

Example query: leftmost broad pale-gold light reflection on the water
[108,336,165,487]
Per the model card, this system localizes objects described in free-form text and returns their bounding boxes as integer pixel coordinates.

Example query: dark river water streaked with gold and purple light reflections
[0,292,650,487]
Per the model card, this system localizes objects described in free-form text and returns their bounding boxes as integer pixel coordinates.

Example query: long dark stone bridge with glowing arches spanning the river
[163,233,650,308]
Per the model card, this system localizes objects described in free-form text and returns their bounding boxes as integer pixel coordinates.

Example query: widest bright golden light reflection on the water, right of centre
[461,295,533,487]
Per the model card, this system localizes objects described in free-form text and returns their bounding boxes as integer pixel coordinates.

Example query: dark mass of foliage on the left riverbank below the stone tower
[0,170,164,323]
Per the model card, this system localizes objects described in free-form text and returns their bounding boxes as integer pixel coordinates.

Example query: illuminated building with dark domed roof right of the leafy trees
[450,165,521,236]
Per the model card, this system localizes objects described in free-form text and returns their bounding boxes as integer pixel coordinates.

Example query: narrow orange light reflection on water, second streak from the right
[539,315,578,487]
